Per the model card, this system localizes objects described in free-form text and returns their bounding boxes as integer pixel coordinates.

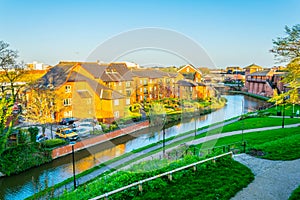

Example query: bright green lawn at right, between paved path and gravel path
[197,127,300,160]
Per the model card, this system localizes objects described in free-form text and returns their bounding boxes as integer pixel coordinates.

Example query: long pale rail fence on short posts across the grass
[91,151,233,200]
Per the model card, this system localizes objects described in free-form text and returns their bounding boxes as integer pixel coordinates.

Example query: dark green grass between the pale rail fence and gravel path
[133,159,254,200]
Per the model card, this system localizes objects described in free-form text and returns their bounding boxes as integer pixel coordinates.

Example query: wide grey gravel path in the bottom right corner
[232,154,300,200]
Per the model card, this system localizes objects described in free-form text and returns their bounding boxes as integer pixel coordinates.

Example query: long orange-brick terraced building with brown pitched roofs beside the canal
[27,62,208,123]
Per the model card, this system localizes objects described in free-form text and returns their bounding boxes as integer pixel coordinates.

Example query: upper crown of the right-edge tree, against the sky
[270,24,300,62]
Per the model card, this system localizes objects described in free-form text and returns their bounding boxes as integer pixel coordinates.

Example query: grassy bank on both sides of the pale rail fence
[48,156,254,199]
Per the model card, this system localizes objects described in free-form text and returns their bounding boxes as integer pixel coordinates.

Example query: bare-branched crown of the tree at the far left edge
[0,41,29,100]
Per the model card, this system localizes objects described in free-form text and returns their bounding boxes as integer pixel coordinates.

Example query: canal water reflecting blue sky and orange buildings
[0,95,266,200]
